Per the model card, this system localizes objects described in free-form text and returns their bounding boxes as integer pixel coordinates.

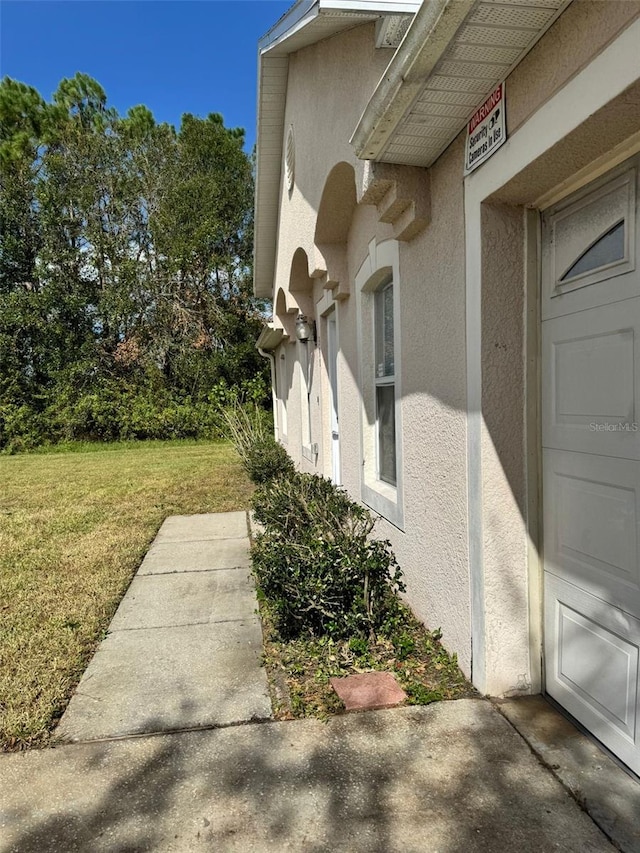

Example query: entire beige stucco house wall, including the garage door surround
[264,0,640,695]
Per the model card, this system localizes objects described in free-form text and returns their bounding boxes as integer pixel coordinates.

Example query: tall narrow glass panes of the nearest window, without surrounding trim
[374,280,396,486]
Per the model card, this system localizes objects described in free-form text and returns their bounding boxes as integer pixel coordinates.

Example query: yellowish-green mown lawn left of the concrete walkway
[0,442,252,750]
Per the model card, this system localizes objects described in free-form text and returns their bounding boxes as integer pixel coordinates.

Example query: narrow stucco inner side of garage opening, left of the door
[481,204,535,694]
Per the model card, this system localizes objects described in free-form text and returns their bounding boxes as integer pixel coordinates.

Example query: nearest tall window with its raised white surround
[355,233,404,529]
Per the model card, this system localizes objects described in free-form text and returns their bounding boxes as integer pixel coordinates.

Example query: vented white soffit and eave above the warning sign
[351,0,571,166]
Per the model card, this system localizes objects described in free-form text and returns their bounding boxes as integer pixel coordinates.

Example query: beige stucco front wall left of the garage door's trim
[268,25,471,674]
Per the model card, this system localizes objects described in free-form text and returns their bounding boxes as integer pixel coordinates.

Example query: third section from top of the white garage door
[543,451,640,614]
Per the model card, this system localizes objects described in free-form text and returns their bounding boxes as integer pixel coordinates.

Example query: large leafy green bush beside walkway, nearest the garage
[252,473,404,639]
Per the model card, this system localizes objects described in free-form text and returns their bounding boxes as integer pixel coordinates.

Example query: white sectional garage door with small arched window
[542,151,640,774]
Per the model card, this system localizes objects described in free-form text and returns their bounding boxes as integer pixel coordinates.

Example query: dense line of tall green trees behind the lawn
[0,74,267,449]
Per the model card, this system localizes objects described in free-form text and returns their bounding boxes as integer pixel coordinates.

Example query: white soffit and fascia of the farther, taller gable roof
[253,0,420,298]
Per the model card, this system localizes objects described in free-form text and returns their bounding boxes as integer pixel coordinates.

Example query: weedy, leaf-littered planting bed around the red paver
[260,600,476,719]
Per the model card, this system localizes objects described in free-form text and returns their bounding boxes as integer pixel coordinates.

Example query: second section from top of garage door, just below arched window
[542,299,640,459]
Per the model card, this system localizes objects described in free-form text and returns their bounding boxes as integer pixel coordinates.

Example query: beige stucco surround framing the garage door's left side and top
[465,11,640,695]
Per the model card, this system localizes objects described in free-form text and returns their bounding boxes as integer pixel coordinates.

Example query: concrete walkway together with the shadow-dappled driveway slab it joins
[0,513,640,853]
